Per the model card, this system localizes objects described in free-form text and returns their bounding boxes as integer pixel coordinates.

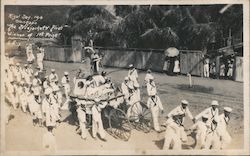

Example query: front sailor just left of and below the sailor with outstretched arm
[190,114,209,149]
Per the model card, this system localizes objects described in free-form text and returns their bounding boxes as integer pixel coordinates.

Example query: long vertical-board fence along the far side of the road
[45,46,203,76]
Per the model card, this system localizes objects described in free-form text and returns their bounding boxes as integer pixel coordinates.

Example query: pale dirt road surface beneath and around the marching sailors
[6,61,244,151]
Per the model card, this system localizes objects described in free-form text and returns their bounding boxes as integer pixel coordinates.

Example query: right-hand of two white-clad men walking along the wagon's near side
[91,99,107,141]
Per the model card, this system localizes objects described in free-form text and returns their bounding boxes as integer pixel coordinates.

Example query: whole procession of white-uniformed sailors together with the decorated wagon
[4,44,233,150]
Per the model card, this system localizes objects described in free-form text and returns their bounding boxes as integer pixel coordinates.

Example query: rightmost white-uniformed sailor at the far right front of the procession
[218,107,232,149]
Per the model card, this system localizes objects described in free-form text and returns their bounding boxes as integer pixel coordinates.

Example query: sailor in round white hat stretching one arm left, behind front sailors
[195,100,219,125]
